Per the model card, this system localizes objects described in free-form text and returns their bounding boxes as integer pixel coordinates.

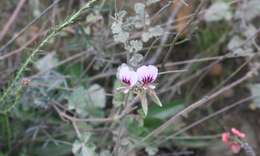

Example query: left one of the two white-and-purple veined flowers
[117,64,138,93]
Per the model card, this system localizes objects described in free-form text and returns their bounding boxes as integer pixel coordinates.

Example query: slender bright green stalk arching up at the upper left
[0,0,97,114]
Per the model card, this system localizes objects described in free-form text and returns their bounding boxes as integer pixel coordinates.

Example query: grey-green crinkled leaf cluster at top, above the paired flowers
[111,0,163,53]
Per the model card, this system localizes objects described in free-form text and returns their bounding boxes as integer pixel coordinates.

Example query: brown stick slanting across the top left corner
[0,0,26,41]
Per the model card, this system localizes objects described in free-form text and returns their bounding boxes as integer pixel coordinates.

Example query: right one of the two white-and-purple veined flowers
[136,65,158,89]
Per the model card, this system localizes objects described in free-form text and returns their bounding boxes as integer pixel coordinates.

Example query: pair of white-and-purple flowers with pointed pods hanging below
[117,64,162,115]
